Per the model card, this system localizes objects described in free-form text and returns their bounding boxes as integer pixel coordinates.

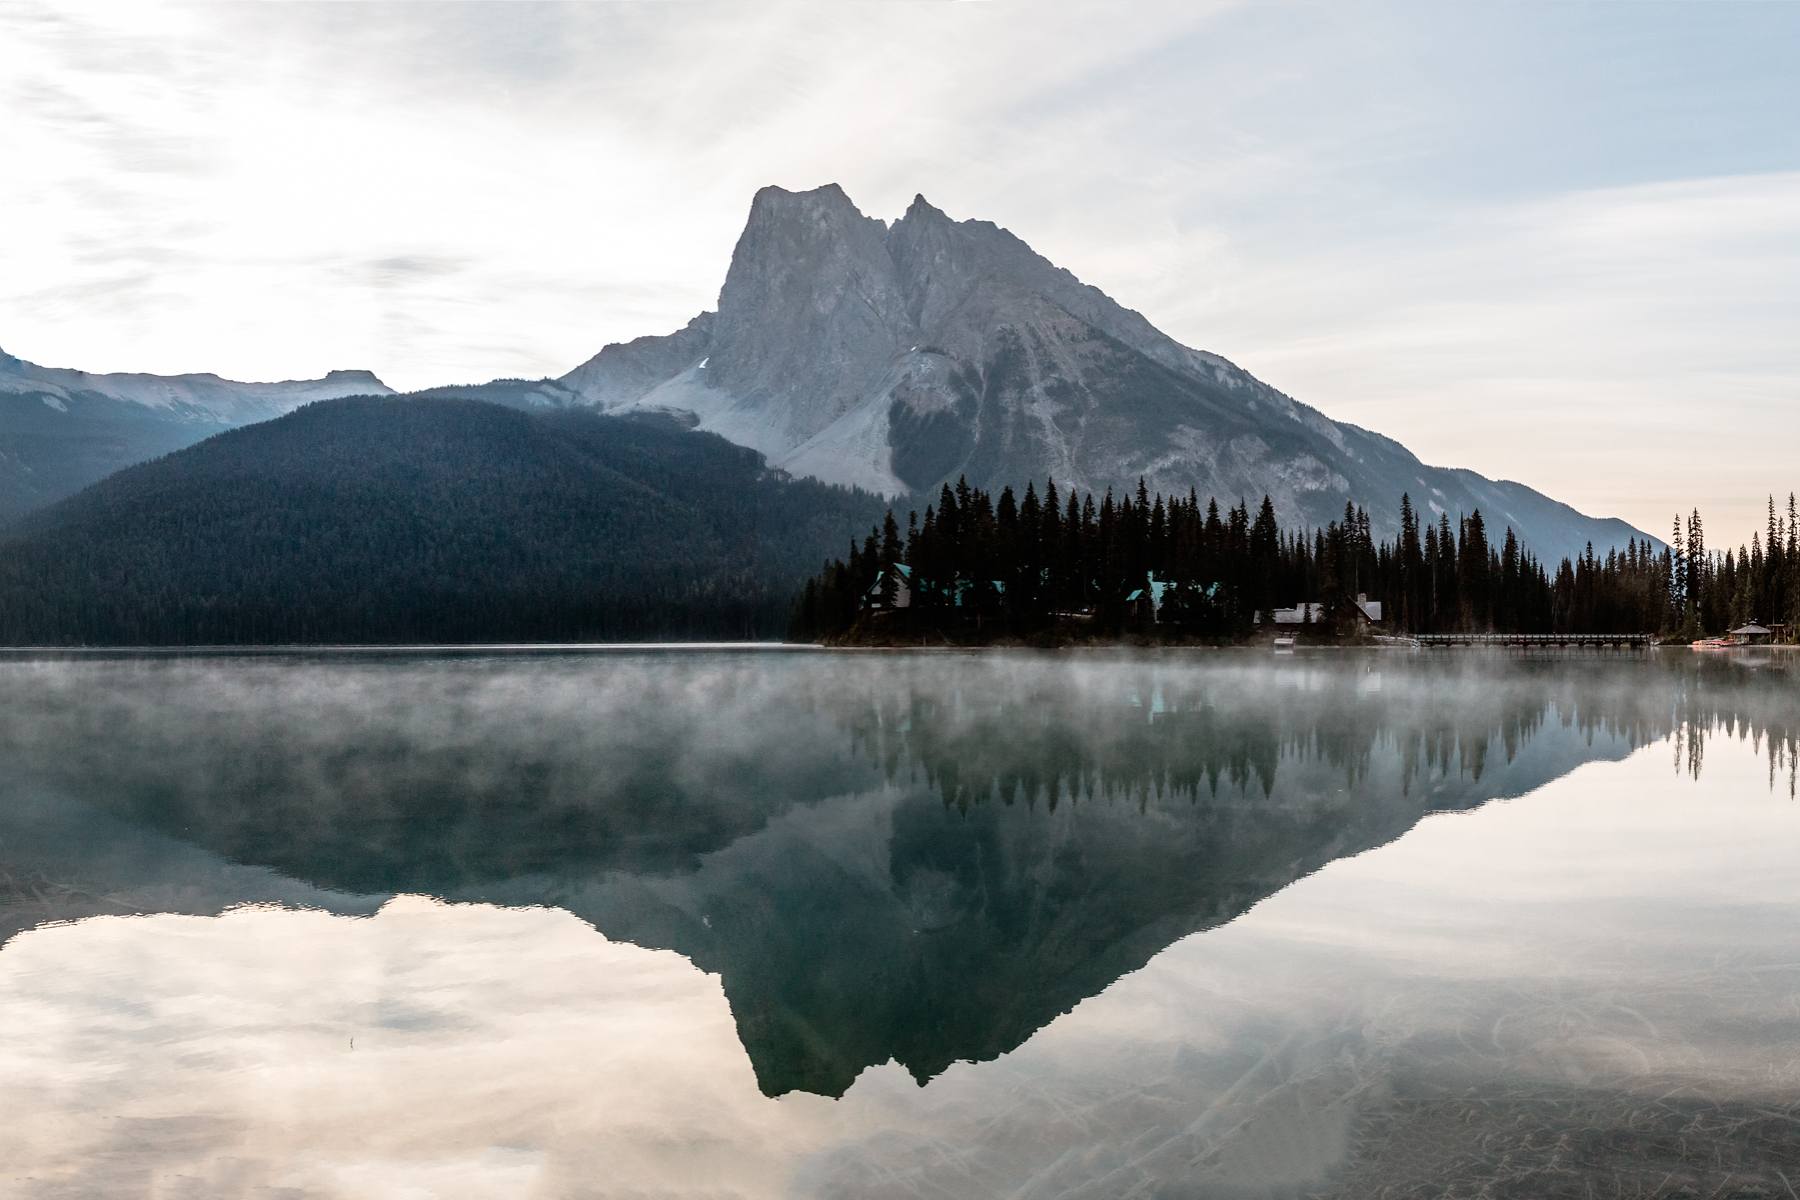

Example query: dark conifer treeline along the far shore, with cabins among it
[790,480,1800,640]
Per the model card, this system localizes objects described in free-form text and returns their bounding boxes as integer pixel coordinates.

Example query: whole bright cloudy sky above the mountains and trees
[0,0,1800,545]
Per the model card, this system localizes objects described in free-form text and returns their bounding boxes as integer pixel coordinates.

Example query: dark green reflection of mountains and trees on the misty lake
[0,651,1800,1096]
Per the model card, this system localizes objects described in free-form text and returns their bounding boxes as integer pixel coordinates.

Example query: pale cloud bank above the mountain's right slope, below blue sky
[1161,173,1800,542]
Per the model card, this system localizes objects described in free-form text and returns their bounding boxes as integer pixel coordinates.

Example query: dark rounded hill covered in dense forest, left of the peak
[0,396,884,646]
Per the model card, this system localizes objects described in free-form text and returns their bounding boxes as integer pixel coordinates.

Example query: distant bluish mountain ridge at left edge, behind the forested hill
[0,351,391,524]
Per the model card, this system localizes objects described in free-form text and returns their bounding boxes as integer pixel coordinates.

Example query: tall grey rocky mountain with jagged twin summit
[558,184,1647,561]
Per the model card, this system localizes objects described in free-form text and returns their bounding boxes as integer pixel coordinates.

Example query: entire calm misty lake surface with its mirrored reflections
[0,649,1800,1200]
